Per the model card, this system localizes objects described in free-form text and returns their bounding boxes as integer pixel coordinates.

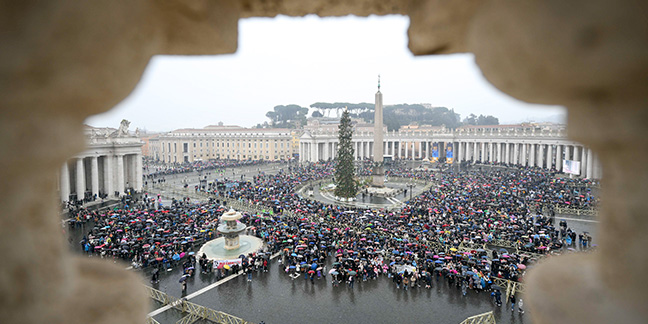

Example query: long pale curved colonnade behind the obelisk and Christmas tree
[299,126,602,179]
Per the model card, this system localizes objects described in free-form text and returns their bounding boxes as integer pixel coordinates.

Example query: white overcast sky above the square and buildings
[86,16,565,131]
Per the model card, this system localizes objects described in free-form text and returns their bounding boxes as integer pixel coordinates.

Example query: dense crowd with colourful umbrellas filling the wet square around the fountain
[67,162,596,311]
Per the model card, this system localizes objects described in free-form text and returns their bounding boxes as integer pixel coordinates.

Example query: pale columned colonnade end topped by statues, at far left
[59,120,143,201]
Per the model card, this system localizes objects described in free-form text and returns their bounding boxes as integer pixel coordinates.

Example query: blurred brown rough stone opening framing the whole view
[0,0,648,323]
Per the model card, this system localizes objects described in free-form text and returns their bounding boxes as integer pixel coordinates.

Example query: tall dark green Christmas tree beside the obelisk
[335,109,358,198]
